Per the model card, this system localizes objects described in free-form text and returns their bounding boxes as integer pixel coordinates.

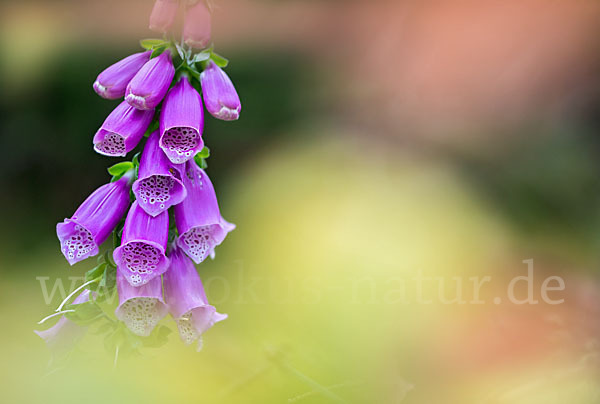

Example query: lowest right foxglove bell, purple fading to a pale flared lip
[164,247,227,345]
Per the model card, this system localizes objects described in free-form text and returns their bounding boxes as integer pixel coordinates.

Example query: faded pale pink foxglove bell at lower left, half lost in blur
[34,290,90,357]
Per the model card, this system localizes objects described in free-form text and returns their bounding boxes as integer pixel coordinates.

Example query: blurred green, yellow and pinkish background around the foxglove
[0,0,600,404]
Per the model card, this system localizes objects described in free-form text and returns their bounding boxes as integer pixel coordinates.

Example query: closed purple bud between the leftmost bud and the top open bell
[125,49,175,110]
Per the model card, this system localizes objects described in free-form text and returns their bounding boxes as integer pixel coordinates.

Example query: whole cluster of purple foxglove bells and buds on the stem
[35,0,241,354]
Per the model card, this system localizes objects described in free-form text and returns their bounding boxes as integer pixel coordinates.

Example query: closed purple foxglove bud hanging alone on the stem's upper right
[200,60,242,121]
